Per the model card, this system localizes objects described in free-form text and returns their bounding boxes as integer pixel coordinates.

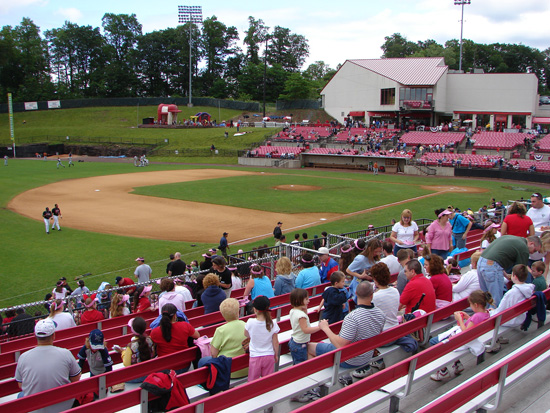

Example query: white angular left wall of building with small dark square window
[322,61,399,122]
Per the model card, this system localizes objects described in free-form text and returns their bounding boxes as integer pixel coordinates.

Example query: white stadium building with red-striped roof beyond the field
[321,57,539,130]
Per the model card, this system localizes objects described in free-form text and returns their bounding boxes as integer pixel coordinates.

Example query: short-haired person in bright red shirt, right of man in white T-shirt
[399,260,436,313]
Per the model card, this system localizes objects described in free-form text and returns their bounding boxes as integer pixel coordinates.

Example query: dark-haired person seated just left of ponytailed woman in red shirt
[114,317,157,383]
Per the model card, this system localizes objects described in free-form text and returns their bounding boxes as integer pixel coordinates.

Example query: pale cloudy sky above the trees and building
[0,0,550,69]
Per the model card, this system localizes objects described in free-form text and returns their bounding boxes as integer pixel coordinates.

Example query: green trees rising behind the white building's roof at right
[381,33,550,94]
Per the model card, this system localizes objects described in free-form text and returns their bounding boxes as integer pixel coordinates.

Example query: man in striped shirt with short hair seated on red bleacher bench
[312,282,385,386]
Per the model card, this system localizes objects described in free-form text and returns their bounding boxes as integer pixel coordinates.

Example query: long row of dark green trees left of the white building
[0,13,334,101]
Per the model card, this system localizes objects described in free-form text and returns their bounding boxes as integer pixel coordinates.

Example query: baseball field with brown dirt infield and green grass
[0,159,548,308]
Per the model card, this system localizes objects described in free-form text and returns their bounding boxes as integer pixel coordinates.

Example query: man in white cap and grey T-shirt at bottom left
[15,318,81,413]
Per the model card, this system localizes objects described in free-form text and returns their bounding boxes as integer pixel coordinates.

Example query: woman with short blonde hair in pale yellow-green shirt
[199,298,248,379]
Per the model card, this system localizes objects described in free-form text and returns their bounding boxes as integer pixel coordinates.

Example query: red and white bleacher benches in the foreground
[0,231,550,413]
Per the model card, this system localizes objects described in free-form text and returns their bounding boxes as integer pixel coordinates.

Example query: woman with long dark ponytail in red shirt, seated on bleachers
[151,302,201,374]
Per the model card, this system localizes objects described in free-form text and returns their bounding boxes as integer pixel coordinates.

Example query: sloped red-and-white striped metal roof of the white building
[348,57,448,86]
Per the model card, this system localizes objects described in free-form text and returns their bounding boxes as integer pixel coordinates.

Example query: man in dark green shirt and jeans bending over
[477,235,542,306]
